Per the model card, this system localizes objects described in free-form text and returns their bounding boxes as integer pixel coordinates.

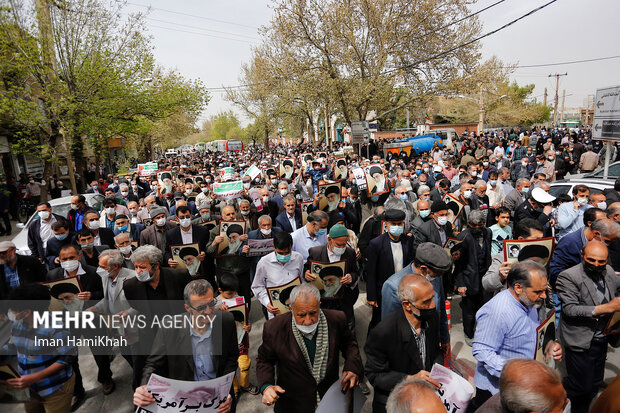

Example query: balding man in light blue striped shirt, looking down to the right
[467,260,562,412]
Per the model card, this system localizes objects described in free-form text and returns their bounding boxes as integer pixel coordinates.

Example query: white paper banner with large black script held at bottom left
[138,372,235,413]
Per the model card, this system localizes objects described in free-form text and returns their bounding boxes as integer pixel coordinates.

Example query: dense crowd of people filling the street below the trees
[0,129,620,413]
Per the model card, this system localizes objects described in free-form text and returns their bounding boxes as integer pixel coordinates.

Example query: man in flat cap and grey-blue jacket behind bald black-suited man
[381,242,452,351]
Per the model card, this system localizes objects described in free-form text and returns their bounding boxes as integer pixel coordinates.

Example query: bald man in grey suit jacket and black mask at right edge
[556,241,620,413]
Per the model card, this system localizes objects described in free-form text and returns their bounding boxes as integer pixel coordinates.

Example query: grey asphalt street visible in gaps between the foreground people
[0,222,620,413]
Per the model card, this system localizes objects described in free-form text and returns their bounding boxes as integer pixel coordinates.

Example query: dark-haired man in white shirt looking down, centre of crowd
[252,231,304,319]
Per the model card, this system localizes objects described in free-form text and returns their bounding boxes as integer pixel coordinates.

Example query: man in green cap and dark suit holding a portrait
[304,224,359,333]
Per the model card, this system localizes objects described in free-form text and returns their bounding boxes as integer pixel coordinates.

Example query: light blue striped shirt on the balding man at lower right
[472,290,540,394]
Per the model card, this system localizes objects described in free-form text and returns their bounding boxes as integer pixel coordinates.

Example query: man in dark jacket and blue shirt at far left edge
[0,241,45,300]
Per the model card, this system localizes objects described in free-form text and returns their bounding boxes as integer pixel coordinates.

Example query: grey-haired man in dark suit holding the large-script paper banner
[134,280,239,413]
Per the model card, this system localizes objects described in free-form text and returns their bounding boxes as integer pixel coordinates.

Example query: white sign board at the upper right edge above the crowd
[592,86,620,141]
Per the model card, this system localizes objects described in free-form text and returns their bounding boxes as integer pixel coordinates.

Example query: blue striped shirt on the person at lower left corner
[2,323,77,397]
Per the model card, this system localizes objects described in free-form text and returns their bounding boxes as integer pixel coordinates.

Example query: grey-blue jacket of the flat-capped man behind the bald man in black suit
[381,263,450,344]
